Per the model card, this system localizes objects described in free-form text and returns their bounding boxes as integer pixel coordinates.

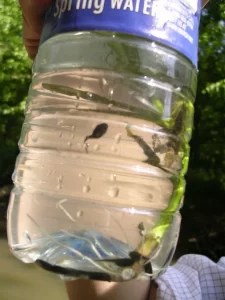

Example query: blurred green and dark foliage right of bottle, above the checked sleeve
[177,0,225,261]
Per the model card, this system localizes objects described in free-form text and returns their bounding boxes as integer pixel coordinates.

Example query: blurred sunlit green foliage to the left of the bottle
[0,0,31,186]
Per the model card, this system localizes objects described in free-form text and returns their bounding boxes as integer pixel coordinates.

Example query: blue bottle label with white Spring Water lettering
[41,0,202,66]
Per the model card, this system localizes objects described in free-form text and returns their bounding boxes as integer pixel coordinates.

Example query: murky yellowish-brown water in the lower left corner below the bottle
[0,239,68,300]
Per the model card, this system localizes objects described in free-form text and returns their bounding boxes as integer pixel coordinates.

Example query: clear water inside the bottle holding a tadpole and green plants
[8,69,193,281]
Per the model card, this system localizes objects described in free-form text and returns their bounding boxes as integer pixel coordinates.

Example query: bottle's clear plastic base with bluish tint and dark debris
[9,230,176,282]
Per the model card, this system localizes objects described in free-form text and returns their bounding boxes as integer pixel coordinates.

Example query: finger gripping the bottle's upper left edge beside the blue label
[19,0,54,59]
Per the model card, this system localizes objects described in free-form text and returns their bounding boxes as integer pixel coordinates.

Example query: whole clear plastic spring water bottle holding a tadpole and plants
[8,0,201,281]
